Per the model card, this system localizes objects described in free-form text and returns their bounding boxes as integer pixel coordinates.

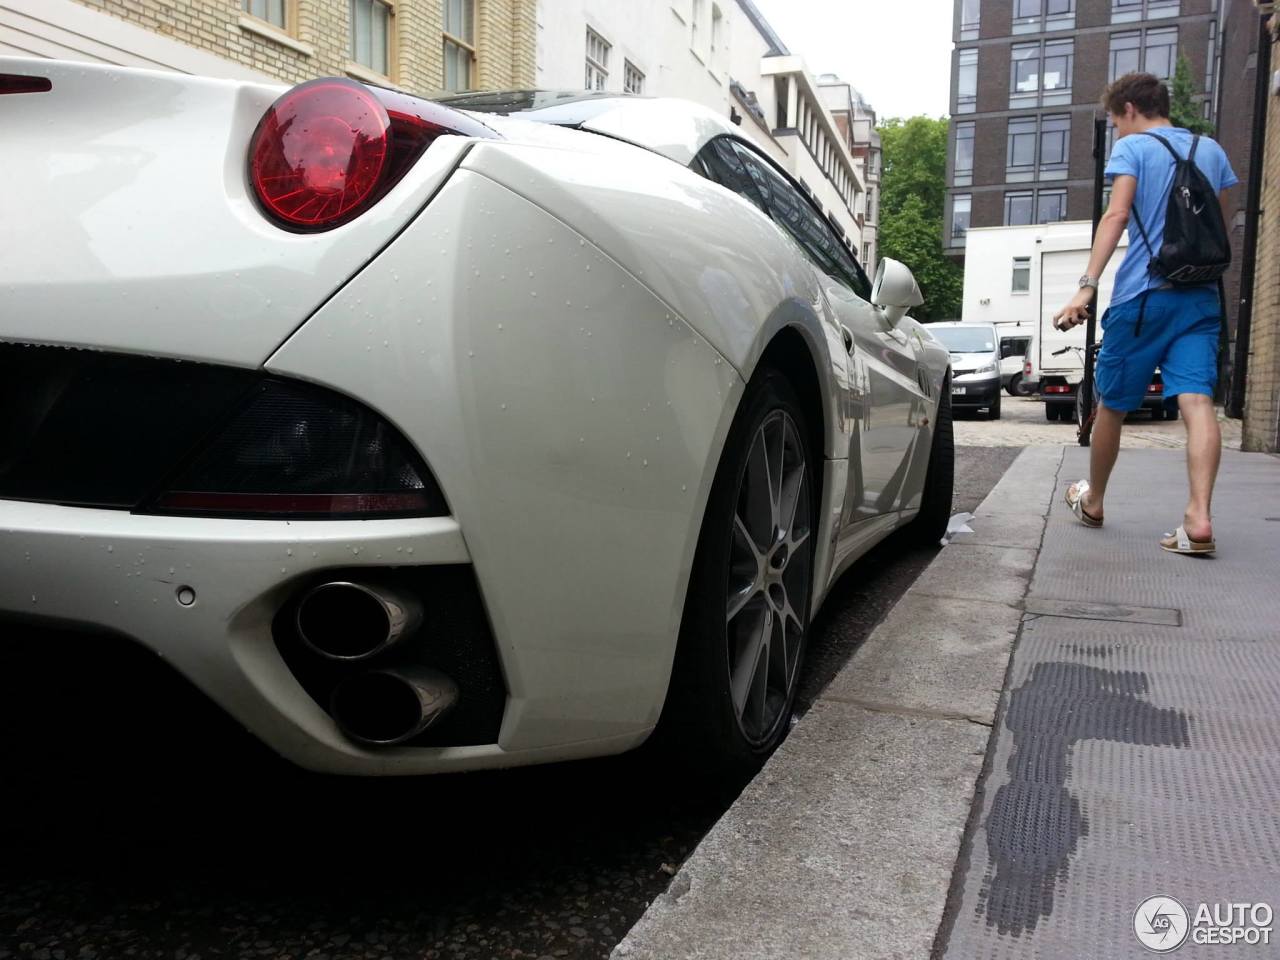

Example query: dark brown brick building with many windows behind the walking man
[945,0,1219,256]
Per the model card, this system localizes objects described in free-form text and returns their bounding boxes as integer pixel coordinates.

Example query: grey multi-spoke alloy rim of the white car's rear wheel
[724,410,812,746]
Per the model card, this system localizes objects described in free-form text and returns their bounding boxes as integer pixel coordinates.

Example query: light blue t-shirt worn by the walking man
[1106,127,1239,303]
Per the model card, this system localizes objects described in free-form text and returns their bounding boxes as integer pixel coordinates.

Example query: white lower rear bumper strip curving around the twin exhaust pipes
[0,500,643,774]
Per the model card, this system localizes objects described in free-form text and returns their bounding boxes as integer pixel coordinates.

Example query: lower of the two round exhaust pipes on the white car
[329,667,458,746]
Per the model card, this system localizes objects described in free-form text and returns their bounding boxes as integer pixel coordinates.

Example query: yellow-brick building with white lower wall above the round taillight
[0,0,536,93]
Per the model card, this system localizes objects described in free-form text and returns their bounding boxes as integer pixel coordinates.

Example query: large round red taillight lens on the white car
[250,79,392,229]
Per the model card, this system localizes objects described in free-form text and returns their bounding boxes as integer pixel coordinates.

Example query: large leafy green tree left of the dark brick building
[879,116,964,323]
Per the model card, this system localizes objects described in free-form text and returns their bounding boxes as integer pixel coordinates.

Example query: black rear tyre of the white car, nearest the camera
[655,367,819,787]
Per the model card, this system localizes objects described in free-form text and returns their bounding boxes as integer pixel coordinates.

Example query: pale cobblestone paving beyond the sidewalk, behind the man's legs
[955,393,1240,451]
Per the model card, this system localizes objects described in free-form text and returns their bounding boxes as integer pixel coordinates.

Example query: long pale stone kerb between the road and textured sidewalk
[611,447,1062,960]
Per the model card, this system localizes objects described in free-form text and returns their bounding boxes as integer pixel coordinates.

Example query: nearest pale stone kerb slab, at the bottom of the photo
[613,700,988,960]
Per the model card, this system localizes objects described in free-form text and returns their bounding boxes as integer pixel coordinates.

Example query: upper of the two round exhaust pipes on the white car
[296,581,422,660]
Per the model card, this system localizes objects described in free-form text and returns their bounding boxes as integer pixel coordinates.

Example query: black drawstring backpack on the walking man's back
[1133,131,1231,333]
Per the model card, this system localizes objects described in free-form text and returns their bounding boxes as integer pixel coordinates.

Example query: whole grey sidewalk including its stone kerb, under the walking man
[614,448,1280,960]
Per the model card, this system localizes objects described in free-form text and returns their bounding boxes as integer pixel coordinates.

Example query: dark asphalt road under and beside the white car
[0,447,1018,960]
